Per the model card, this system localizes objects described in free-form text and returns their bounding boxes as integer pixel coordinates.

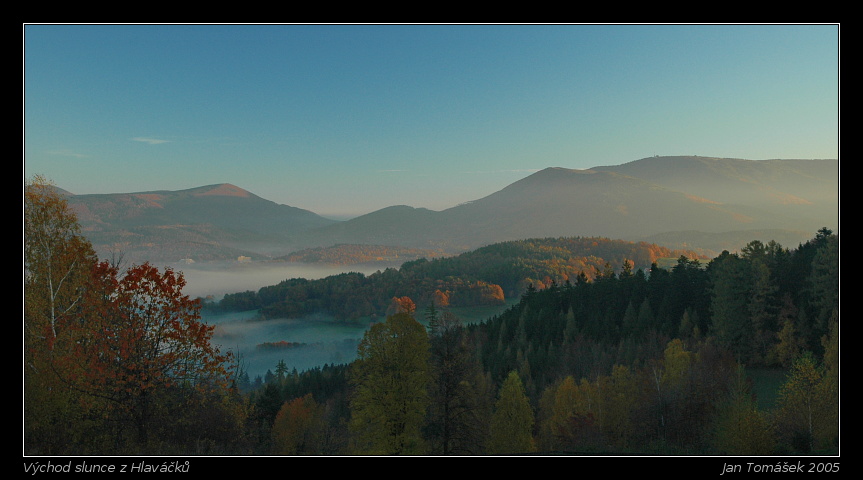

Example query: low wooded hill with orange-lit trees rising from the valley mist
[210,237,698,319]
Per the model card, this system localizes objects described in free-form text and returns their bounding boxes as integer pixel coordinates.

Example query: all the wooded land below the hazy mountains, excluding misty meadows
[24,179,839,455]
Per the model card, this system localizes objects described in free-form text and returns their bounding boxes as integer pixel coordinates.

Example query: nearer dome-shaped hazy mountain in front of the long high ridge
[444,168,768,241]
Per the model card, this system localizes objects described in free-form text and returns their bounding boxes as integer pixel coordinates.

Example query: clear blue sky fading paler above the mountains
[22,25,839,215]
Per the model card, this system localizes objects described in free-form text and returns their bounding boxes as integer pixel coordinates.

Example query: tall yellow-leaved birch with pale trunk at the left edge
[24,177,95,453]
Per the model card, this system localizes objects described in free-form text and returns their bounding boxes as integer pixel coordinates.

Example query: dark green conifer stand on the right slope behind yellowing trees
[477,229,839,387]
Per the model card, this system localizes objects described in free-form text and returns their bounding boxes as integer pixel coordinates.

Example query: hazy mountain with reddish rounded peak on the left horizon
[68,184,335,263]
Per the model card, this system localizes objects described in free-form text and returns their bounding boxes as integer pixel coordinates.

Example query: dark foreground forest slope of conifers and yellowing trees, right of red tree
[241,229,839,456]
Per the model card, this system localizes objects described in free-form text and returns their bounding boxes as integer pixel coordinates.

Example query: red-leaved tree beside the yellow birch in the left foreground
[65,262,231,444]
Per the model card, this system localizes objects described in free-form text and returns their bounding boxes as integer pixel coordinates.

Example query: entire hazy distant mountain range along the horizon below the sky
[68,156,839,263]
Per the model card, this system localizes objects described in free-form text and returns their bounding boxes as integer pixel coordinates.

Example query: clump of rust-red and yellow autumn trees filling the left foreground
[24,177,241,454]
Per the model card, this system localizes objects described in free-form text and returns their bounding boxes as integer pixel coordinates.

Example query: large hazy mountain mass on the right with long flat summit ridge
[296,157,839,253]
